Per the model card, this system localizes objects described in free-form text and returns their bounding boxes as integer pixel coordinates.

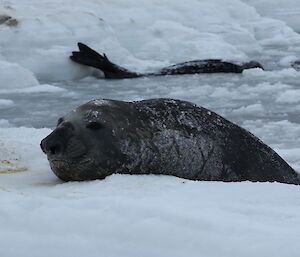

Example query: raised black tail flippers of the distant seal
[70,43,142,79]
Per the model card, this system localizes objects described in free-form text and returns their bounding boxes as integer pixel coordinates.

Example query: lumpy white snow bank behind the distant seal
[0,0,300,87]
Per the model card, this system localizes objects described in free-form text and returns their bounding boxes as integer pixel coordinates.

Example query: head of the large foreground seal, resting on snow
[41,100,122,181]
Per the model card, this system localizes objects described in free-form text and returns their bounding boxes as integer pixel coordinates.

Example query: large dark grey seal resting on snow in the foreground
[41,98,300,185]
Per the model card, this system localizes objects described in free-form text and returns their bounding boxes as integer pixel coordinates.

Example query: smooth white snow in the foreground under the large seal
[0,123,300,257]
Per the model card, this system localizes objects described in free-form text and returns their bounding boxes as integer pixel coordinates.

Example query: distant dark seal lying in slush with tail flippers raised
[70,43,263,79]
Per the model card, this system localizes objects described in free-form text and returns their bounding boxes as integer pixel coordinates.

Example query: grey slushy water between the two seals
[2,71,300,128]
